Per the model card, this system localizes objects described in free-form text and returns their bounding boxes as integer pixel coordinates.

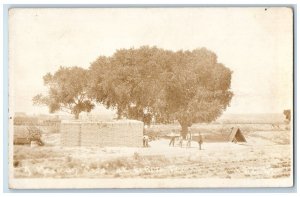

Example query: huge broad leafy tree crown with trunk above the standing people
[90,46,233,137]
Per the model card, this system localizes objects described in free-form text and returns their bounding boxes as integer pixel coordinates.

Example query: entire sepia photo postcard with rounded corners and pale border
[8,7,295,189]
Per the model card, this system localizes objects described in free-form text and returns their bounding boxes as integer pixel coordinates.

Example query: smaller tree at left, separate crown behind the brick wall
[32,67,94,119]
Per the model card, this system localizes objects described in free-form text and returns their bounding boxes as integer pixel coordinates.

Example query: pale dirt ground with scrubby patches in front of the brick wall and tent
[14,131,292,179]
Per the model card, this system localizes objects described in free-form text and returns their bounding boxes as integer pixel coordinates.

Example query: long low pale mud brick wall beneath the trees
[61,120,144,147]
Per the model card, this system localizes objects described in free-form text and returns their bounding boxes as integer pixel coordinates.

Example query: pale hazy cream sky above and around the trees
[9,8,293,113]
